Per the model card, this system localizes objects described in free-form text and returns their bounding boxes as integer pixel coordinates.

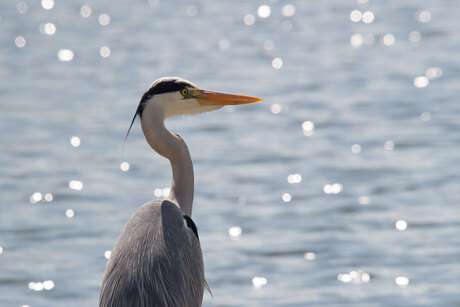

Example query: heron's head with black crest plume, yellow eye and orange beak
[125,77,262,140]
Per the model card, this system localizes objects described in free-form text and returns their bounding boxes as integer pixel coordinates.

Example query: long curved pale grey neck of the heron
[141,107,194,216]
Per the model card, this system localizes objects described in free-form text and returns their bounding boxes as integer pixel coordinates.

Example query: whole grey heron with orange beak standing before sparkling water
[99,78,262,307]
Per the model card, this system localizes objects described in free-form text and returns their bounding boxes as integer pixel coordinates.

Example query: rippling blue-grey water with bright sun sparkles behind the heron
[0,0,460,307]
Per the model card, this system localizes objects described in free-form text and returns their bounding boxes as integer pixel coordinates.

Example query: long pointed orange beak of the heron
[193,90,262,106]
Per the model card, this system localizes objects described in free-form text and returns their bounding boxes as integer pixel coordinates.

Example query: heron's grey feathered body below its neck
[99,200,207,307]
